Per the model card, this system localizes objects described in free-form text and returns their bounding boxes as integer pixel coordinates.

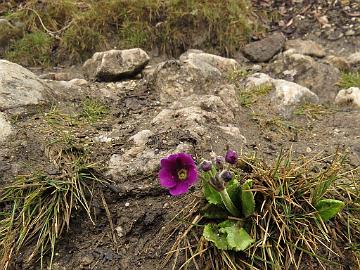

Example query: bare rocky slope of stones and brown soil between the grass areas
[0,33,360,269]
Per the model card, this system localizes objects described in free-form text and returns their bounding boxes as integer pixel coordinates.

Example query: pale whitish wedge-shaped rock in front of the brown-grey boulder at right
[272,80,319,114]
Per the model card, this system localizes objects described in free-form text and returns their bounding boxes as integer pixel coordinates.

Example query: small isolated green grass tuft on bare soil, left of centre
[81,98,109,123]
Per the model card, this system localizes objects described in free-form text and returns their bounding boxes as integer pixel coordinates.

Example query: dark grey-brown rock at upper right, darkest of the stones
[243,33,286,62]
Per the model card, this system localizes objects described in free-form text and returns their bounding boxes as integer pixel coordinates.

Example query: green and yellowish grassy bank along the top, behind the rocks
[6,0,260,65]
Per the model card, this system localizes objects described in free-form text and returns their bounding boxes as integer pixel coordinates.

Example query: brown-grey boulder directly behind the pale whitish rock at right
[269,50,340,101]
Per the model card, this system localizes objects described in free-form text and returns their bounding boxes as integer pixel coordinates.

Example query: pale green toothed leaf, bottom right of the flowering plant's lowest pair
[219,224,255,251]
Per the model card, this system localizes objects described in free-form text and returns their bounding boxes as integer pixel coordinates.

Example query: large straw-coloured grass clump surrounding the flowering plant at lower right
[164,152,360,270]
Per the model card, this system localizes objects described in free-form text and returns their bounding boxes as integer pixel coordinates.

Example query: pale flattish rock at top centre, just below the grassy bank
[179,50,240,78]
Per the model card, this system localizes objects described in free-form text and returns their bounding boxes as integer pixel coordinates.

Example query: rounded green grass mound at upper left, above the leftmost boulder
[5,32,53,66]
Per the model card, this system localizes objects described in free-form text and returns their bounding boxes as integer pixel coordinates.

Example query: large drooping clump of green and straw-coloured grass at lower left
[0,140,103,269]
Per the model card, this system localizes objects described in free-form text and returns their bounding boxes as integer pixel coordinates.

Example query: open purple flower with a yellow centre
[159,153,198,196]
